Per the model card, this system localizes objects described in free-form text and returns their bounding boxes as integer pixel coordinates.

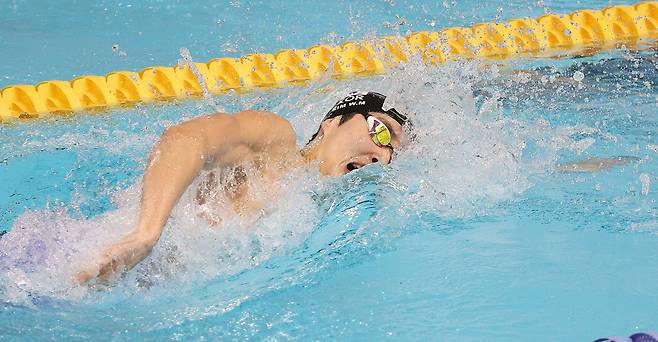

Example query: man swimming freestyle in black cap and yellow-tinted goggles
[76,92,409,283]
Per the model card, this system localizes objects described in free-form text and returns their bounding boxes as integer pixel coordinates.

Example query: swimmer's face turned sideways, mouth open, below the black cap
[318,112,404,176]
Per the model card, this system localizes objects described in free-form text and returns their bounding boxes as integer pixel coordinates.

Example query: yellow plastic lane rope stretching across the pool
[0,2,658,121]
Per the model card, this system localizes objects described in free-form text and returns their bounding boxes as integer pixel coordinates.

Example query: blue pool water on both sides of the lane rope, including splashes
[0,1,658,341]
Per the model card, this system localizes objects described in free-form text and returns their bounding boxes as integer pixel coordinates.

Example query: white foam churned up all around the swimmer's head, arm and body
[0,60,592,304]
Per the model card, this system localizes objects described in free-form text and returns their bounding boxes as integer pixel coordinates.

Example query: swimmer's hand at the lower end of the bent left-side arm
[74,231,157,284]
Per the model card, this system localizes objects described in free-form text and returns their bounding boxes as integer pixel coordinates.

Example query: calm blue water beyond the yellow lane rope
[0,0,634,88]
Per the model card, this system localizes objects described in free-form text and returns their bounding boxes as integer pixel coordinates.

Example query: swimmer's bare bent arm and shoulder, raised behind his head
[76,111,296,283]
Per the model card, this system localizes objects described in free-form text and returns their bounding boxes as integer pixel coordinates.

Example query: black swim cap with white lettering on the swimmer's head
[322,91,409,126]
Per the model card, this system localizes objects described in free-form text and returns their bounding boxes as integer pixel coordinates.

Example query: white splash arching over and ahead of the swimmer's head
[294,61,580,216]
